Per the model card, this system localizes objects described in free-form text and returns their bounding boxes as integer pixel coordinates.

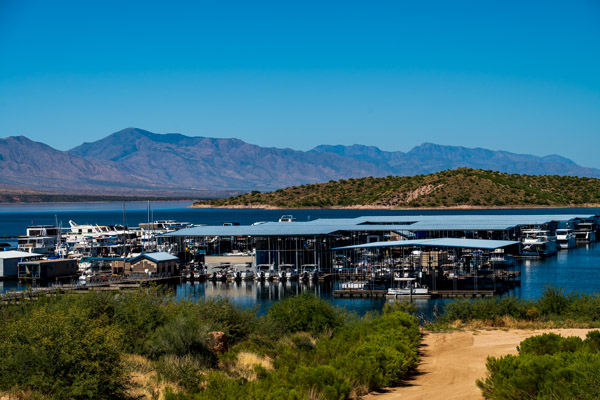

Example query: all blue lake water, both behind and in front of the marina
[0,202,600,315]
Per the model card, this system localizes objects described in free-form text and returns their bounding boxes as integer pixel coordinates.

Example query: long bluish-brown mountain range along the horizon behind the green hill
[0,128,600,196]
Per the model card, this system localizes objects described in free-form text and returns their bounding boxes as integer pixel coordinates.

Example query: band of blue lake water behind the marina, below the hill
[0,201,600,238]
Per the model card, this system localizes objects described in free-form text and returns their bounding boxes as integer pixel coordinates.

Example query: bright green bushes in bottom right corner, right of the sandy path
[477,331,600,399]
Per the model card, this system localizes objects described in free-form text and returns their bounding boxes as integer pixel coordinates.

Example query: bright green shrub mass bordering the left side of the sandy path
[173,308,420,400]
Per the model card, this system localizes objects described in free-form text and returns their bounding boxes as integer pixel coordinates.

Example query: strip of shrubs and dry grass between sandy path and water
[431,287,600,329]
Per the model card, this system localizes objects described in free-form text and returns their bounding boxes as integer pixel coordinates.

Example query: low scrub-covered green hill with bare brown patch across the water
[195,168,600,208]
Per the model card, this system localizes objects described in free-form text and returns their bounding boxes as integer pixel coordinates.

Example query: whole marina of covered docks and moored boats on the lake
[0,202,598,314]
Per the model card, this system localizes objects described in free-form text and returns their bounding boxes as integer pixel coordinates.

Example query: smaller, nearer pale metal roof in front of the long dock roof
[332,238,521,250]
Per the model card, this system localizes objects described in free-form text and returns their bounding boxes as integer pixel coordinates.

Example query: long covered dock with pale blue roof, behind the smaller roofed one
[160,214,599,269]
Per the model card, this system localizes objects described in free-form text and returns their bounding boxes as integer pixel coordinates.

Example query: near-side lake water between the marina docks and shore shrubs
[0,244,600,319]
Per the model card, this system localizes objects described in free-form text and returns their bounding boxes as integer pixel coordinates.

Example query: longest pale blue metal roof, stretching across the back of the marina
[163,214,596,236]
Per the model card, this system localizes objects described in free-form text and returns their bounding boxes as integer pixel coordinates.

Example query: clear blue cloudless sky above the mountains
[0,0,600,168]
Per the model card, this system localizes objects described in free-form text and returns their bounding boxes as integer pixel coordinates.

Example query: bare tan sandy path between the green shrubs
[363,329,589,400]
